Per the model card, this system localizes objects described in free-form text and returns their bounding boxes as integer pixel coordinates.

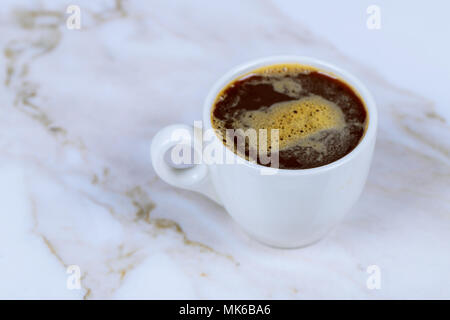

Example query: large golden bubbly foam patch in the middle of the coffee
[233,95,345,151]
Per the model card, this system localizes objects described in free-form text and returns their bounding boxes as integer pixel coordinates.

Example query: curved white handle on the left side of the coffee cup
[150,124,222,205]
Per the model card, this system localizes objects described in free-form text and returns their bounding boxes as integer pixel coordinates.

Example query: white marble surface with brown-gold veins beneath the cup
[0,0,450,299]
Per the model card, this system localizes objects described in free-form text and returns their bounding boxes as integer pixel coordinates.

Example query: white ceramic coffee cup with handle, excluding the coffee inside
[151,56,377,248]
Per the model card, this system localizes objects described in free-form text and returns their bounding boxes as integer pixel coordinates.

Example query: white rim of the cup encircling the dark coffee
[203,55,378,176]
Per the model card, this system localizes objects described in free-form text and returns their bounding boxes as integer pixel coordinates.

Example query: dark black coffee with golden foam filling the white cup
[211,64,367,169]
